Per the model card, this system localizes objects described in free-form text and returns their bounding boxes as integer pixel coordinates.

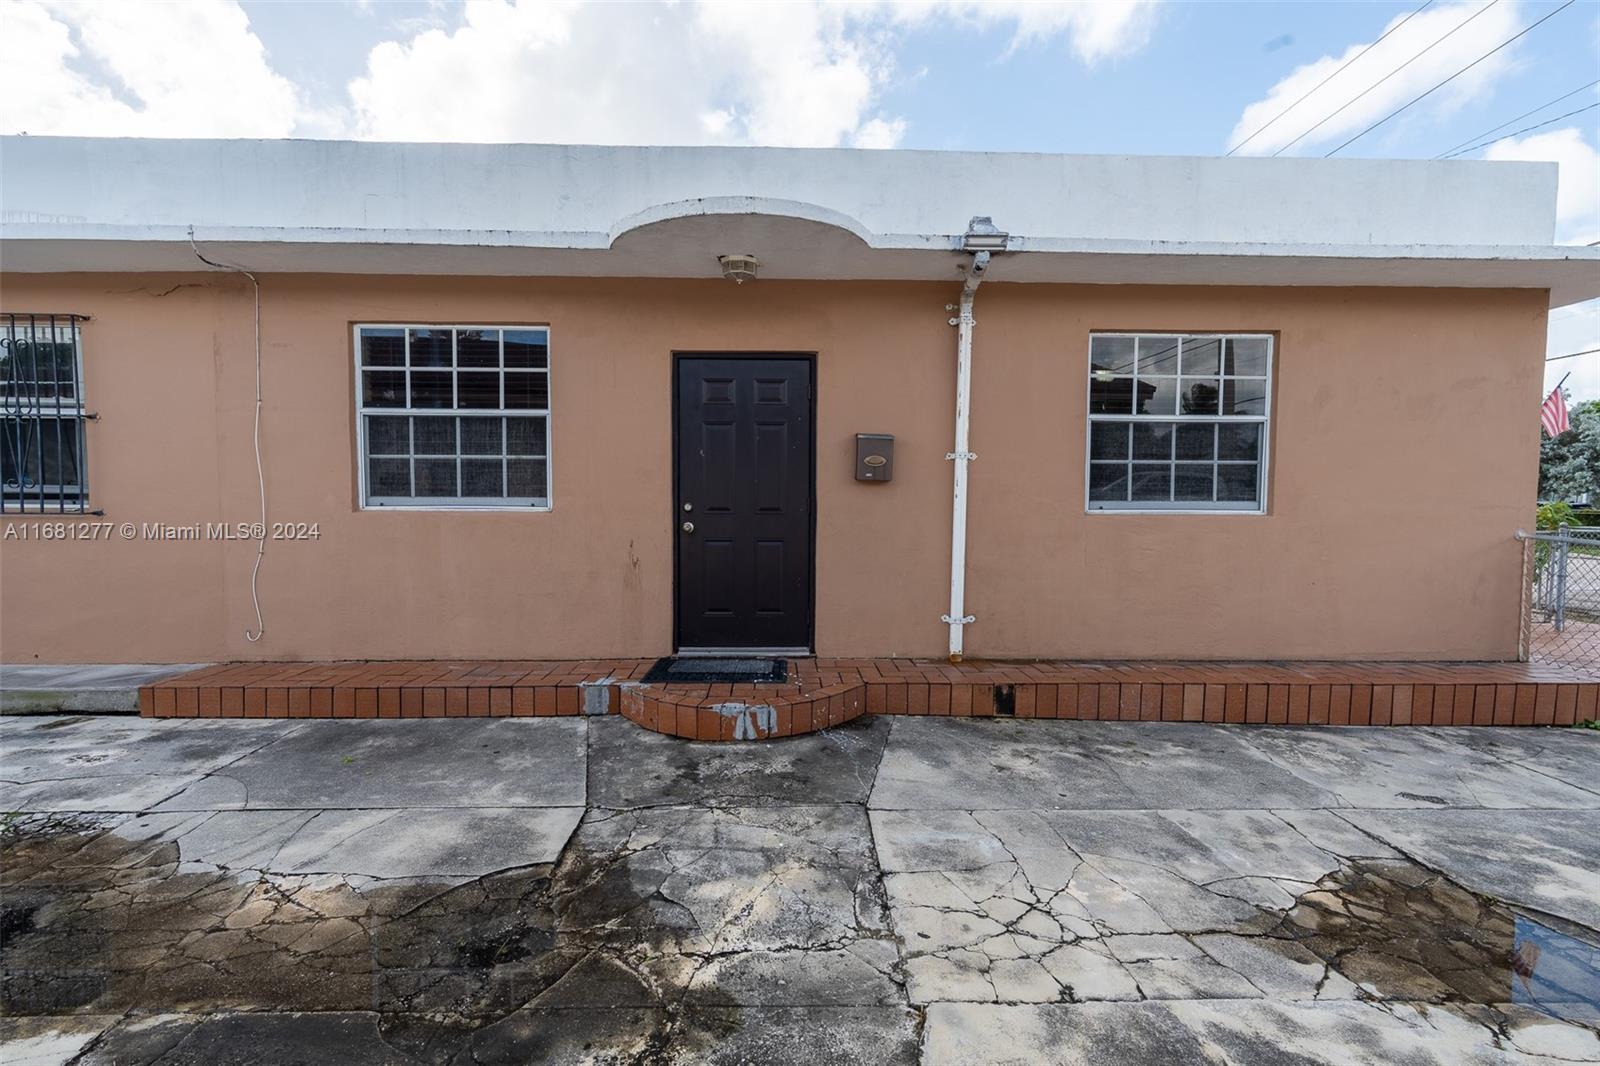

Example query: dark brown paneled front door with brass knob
[674,355,813,648]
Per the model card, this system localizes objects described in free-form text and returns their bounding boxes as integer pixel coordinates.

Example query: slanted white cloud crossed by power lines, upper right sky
[1227,0,1523,155]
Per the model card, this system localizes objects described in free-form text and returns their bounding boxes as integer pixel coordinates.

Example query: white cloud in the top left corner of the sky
[0,0,304,138]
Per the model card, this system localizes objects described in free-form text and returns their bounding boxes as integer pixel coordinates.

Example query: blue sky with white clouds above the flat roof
[0,0,1600,399]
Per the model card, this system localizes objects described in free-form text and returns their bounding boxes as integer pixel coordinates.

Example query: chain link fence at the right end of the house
[1517,525,1600,669]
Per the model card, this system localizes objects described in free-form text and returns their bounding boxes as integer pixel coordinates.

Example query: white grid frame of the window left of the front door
[350,322,555,514]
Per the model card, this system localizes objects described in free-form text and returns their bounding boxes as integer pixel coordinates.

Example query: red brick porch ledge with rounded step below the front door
[139,659,1600,739]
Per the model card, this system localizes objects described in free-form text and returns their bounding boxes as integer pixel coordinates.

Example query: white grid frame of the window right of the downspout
[1083,330,1278,515]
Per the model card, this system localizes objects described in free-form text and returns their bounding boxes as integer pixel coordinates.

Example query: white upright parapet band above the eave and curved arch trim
[0,136,1555,245]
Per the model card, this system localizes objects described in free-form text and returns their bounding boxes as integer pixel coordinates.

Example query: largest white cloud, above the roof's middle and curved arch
[350,0,1154,147]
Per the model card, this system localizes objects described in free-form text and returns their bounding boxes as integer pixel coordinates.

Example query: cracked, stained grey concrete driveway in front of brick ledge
[0,717,1600,1066]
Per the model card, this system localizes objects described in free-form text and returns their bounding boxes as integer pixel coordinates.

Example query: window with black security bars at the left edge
[0,312,88,514]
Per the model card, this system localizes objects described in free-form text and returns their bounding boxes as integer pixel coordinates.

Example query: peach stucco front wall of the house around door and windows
[0,275,1546,663]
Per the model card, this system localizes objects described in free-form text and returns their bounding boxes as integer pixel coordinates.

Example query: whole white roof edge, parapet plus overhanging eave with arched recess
[0,136,1600,299]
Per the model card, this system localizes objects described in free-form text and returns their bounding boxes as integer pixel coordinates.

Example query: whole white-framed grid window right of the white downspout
[1086,333,1272,514]
